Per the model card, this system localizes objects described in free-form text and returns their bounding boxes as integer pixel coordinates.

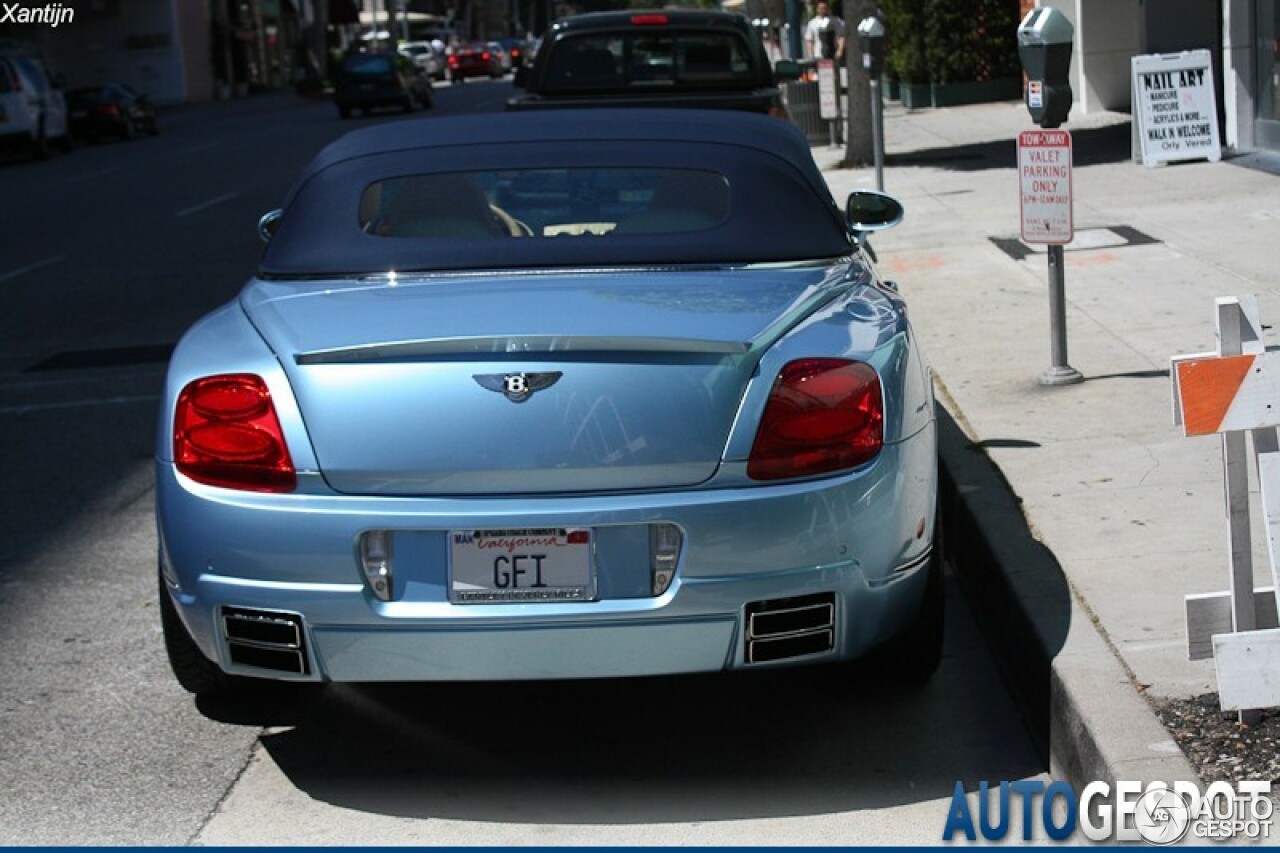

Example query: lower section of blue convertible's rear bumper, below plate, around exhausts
[175,558,925,681]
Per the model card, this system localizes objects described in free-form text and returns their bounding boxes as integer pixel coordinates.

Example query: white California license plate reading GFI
[449,528,595,605]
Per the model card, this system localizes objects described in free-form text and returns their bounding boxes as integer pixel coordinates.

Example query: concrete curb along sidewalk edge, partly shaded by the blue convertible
[938,389,1199,792]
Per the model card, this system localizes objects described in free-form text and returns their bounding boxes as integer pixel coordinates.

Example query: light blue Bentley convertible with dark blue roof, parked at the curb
[156,110,942,694]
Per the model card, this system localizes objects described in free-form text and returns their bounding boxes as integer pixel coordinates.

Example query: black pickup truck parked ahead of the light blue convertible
[507,10,800,118]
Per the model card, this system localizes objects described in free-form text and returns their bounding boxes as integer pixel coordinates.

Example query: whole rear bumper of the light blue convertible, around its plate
[157,429,934,681]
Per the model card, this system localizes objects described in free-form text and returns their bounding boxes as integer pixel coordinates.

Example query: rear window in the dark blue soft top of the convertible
[360,168,730,240]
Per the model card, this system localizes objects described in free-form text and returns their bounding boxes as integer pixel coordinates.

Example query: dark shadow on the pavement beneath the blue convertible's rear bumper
[200,579,1046,825]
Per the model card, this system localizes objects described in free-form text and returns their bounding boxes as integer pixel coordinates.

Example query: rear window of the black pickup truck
[543,29,759,92]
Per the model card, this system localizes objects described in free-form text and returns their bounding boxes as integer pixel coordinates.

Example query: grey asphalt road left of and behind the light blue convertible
[0,82,1043,845]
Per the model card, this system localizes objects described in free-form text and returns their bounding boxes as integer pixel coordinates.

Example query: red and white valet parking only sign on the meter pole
[1018,131,1075,243]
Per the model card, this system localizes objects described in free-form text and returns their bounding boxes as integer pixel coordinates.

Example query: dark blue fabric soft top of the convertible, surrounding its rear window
[260,109,852,277]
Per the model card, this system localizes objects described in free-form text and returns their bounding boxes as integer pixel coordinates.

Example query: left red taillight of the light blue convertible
[173,373,297,492]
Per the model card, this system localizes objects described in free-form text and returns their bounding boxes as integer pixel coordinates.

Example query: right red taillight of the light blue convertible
[746,359,884,480]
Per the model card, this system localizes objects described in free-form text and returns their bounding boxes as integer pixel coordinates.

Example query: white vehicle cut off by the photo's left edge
[0,51,72,160]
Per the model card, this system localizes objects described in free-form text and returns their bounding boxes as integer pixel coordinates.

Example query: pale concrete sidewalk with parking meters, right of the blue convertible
[814,102,1280,784]
